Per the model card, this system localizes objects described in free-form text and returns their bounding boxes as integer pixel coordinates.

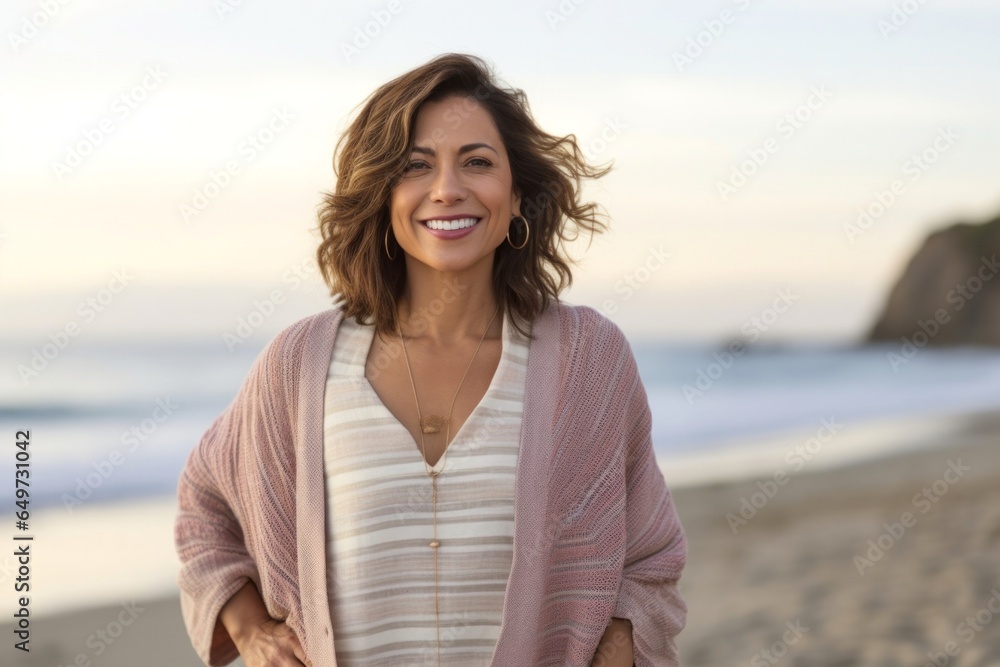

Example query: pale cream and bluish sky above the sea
[0,0,1000,343]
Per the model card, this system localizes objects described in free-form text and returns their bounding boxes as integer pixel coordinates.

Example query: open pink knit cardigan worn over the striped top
[175,301,687,667]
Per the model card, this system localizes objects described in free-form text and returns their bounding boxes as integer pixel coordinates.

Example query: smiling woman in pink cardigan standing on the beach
[176,54,686,667]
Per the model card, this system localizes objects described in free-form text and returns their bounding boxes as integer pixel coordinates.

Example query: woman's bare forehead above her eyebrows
[413,96,501,148]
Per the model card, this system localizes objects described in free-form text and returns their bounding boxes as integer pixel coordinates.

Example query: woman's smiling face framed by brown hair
[390,96,521,271]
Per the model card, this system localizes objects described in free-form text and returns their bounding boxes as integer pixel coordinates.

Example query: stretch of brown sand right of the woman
[675,414,1000,667]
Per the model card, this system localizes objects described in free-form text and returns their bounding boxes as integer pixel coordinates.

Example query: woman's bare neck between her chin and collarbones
[398,258,503,345]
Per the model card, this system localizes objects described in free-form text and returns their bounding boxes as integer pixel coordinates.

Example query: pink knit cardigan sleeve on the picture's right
[612,344,687,667]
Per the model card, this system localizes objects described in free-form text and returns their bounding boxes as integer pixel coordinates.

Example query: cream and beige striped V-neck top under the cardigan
[323,310,530,667]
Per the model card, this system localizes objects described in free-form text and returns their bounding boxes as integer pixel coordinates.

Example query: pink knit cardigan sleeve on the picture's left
[174,325,303,666]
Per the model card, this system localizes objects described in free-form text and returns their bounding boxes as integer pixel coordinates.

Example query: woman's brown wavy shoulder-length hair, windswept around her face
[316,53,612,342]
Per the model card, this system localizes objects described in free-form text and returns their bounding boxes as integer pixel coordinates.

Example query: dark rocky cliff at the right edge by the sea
[868,216,1000,347]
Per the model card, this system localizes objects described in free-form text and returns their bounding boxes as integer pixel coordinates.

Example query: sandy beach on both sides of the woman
[0,413,1000,667]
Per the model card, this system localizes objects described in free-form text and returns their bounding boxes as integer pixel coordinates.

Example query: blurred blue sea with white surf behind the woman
[0,340,1000,513]
